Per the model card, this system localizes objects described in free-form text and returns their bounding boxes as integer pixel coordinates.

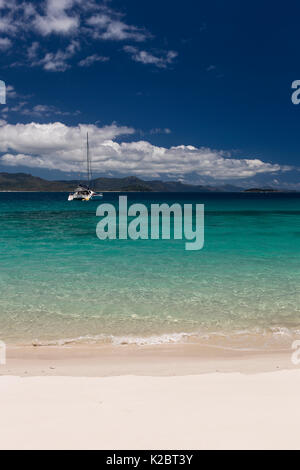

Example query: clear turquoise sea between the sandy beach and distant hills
[0,193,300,344]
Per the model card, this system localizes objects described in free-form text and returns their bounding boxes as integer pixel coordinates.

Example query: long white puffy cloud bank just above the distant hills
[0,122,290,181]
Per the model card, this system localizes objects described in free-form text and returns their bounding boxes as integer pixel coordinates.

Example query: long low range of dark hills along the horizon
[0,173,296,193]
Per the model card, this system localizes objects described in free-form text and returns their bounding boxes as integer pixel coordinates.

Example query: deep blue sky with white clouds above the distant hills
[0,0,300,190]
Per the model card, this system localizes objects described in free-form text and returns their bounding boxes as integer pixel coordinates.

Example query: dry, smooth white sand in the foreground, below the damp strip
[0,362,300,450]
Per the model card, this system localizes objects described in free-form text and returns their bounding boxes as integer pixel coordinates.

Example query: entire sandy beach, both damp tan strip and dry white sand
[0,346,300,450]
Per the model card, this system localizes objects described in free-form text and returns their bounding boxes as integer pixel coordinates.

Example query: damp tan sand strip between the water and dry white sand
[0,343,297,377]
